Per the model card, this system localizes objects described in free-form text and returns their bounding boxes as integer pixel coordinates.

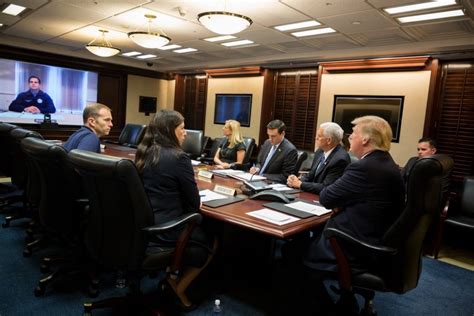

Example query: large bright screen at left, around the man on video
[0,59,98,125]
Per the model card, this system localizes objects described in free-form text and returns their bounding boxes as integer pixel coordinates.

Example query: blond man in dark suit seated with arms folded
[304,116,405,309]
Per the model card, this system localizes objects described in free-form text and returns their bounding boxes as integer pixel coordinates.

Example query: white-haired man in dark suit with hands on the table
[287,122,351,194]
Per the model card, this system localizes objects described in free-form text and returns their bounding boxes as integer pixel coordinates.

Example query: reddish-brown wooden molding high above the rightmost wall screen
[320,56,432,73]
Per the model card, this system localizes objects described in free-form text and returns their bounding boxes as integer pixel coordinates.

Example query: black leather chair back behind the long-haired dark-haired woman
[69,149,154,270]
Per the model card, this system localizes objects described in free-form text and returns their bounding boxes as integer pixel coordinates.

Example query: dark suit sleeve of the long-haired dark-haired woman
[176,155,201,212]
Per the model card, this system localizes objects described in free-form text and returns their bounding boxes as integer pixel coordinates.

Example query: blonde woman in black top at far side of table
[214,120,245,169]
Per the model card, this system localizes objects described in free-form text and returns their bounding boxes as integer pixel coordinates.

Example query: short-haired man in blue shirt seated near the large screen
[64,103,113,153]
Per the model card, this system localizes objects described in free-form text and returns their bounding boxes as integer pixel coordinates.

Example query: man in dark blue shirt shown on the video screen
[8,76,56,114]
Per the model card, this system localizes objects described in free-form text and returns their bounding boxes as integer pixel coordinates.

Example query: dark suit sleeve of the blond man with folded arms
[319,163,367,208]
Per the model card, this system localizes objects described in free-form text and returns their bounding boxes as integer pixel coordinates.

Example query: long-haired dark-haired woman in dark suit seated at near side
[135,109,215,309]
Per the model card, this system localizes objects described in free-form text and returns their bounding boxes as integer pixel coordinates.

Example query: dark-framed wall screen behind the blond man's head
[332,95,405,143]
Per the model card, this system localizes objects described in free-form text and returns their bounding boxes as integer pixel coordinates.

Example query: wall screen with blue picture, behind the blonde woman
[214,94,252,127]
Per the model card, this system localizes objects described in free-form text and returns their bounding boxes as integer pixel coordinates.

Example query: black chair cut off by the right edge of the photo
[434,176,474,259]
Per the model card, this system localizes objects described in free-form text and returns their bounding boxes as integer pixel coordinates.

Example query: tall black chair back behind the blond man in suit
[379,155,453,294]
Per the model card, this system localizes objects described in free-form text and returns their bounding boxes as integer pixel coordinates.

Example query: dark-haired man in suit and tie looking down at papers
[250,120,298,183]
